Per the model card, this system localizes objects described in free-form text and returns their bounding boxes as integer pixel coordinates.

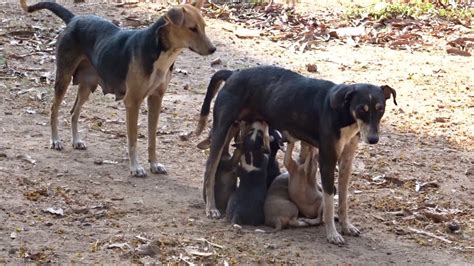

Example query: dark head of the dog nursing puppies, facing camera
[329,84,397,144]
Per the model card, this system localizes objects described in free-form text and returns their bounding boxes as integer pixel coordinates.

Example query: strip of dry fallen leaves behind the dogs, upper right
[207,4,473,56]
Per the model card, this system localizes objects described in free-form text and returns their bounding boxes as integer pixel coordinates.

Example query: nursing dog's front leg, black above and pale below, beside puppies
[319,141,344,245]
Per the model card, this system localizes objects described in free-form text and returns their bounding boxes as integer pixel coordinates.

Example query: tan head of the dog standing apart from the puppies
[164,5,216,55]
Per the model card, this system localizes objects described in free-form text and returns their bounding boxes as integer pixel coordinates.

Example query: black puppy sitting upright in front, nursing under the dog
[226,121,269,225]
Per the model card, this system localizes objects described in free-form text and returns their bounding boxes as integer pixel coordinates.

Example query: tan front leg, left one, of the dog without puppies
[124,95,146,177]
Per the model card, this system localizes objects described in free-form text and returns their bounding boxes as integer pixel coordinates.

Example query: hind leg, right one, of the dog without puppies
[71,84,94,150]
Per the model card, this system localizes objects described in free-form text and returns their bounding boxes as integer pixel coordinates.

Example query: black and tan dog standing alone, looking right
[20,0,216,177]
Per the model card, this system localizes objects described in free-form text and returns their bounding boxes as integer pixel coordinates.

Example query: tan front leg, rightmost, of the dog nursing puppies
[338,136,360,236]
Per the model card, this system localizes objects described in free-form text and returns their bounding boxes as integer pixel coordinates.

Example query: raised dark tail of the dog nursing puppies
[194,69,233,136]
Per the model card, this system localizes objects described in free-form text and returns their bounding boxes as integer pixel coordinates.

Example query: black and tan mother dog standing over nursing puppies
[196,66,396,244]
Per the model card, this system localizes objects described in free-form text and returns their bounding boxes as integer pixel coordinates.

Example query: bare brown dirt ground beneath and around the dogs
[0,0,474,265]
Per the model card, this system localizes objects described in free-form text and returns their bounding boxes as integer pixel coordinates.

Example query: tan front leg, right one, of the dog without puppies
[148,84,167,174]
